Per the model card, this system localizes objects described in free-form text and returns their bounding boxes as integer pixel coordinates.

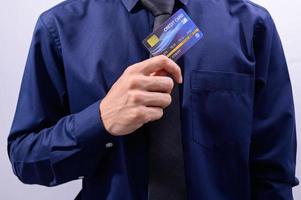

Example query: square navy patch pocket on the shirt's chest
[190,70,253,148]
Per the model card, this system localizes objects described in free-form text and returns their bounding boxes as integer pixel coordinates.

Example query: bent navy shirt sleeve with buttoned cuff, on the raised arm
[8,14,116,186]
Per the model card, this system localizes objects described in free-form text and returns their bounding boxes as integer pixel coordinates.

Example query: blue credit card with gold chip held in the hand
[143,9,203,61]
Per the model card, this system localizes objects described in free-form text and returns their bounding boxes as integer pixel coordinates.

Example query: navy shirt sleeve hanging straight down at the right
[250,9,298,200]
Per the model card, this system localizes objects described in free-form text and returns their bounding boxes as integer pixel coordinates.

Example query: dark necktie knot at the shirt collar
[141,0,175,17]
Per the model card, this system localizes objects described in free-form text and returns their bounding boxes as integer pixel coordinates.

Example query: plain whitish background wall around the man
[0,0,301,200]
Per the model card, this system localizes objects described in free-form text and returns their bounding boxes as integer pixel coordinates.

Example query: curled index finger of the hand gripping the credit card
[141,55,183,83]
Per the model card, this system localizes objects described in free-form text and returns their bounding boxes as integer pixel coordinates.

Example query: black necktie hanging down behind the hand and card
[141,0,186,200]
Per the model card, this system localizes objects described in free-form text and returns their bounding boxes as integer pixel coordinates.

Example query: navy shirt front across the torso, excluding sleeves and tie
[44,0,266,200]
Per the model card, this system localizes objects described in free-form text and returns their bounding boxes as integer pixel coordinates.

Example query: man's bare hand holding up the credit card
[99,55,182,136]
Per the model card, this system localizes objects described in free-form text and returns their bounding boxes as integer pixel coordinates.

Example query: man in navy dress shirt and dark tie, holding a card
[8,0,298,200]
